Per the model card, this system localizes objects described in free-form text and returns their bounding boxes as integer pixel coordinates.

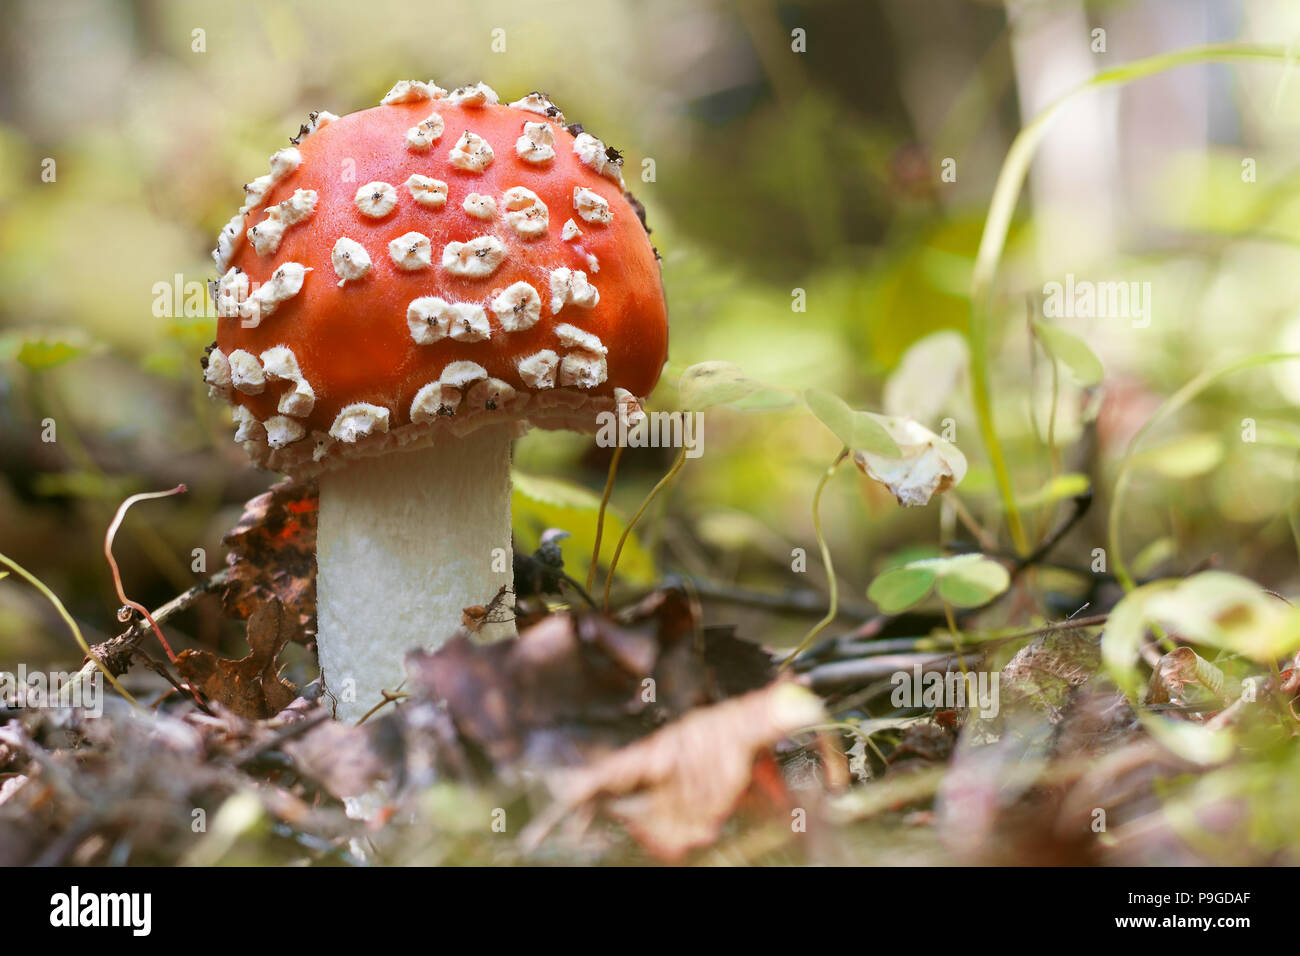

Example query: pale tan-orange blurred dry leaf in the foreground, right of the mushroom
[525,682,826,861]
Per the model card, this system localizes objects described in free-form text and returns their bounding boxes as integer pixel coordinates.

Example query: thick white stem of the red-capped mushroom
[316,425,514,723]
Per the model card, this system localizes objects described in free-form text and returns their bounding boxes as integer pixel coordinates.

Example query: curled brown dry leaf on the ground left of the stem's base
[176,598,298,719]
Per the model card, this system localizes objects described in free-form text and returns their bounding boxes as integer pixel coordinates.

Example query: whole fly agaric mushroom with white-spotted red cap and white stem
[204,81,668,721]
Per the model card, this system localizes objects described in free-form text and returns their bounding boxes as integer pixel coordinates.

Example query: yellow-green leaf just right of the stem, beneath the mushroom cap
[511,471,655,584]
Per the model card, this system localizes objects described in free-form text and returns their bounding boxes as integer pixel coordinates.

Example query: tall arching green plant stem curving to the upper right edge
[969,43,1291,564]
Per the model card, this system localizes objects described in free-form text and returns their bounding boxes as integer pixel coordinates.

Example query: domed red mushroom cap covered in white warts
[205,82,668,473]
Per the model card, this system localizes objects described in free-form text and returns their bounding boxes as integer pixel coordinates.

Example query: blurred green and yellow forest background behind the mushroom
[0,0,1300,666]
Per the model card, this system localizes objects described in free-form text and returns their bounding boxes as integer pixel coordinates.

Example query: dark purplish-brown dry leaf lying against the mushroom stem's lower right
[407,589,772,770]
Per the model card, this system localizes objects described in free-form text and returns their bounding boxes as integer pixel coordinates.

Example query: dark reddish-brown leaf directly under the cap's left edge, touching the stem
[221,479,320,640]
